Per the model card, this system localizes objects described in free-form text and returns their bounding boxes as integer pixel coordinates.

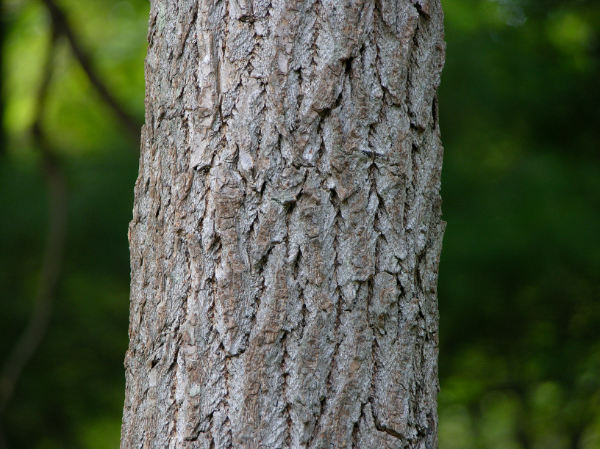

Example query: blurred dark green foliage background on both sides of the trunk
[0,0,600,449]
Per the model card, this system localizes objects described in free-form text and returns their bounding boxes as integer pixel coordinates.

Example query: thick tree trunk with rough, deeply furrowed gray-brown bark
[121,0,444,449]
